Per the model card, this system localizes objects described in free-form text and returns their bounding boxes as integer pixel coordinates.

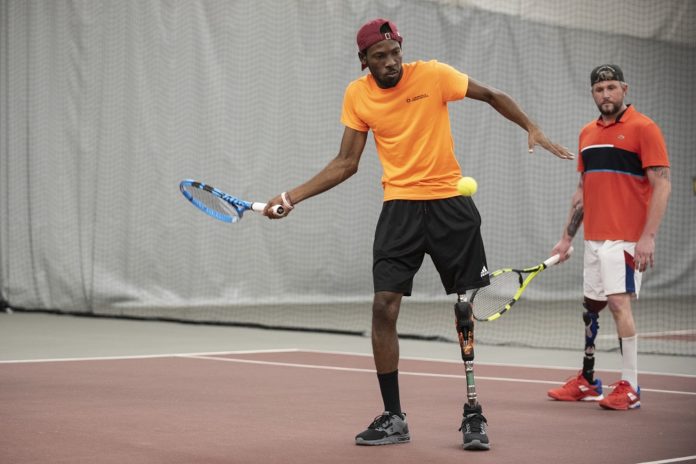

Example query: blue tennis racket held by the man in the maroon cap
[179,179,287,223]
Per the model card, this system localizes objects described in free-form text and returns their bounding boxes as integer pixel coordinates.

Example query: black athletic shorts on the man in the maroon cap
[372,196,489,296]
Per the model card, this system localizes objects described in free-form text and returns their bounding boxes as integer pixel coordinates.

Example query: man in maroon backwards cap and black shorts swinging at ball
[265,18,574,449]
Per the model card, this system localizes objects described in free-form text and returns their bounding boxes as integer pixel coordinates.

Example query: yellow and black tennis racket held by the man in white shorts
[469,247,573,322]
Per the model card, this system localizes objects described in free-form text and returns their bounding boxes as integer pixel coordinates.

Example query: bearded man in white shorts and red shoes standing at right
[548,64,671,410]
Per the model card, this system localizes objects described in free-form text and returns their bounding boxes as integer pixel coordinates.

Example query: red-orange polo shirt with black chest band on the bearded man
[578,105,669,242]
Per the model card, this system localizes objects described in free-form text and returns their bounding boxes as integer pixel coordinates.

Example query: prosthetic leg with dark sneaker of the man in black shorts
[454,294,490,450]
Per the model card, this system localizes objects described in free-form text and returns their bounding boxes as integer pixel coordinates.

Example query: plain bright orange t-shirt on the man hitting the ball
[341,60,469,201]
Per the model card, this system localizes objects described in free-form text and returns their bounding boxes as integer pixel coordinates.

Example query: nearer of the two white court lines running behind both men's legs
[181,355,696,396]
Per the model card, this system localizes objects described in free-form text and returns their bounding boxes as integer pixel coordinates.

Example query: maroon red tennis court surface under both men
[0,350,696,464]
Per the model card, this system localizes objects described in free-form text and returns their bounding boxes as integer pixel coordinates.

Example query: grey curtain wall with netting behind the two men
[0,0,696,355]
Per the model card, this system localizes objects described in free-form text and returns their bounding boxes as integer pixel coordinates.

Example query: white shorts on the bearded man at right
[583,240,642,301]
